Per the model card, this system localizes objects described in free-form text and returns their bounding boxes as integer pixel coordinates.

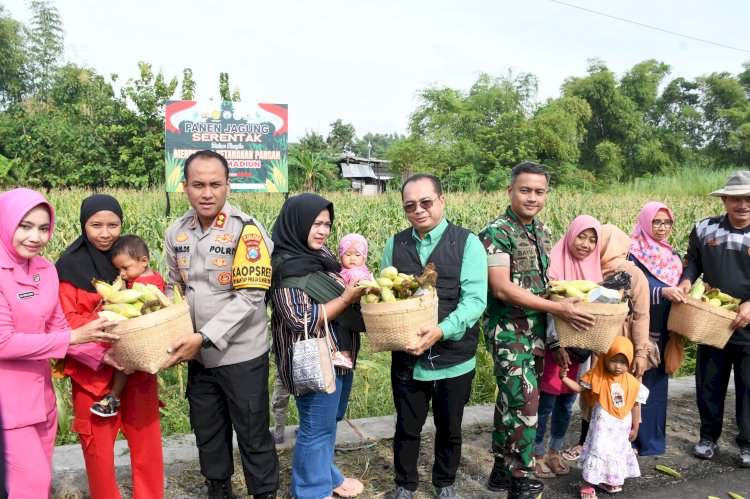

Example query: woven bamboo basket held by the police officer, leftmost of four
[109,302,193,374]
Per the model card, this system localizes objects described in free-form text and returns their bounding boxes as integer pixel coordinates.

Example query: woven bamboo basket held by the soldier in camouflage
[551,295,628,353]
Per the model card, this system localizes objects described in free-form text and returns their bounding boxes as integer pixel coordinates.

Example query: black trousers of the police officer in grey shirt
[187,353,279,495]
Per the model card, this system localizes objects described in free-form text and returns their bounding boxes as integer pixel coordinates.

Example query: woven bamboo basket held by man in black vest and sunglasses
[361,292,438,352]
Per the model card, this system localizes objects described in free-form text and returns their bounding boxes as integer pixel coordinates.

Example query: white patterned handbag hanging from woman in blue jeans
[292,307,336,395]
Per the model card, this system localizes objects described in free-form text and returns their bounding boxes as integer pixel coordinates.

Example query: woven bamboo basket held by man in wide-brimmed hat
[667,296,737,348]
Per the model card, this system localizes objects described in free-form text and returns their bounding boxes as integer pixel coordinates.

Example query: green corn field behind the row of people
[44,182,726,443]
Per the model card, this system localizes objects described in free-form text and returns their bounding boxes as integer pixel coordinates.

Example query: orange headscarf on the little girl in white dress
[581,336,641,419]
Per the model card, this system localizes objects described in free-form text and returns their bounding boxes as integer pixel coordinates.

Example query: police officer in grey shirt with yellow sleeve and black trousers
[165,150,279,498]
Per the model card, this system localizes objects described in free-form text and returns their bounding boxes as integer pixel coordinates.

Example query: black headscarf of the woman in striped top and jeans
[271,193,341,286]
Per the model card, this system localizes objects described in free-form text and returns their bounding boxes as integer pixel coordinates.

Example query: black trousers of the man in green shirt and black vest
[391,370,474,492]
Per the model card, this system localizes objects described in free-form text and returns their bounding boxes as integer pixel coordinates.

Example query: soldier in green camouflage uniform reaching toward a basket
[479,162,593,498]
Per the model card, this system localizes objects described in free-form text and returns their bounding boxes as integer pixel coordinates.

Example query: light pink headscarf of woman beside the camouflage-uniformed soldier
[549,215,602,283]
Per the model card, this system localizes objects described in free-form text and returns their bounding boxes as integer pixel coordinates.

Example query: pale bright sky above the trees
[0,0,750,141]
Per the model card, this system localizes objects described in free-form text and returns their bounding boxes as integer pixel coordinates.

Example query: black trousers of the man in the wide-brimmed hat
[695,343,750,448]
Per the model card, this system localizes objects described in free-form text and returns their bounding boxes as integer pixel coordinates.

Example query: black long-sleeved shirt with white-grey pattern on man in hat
[680,215,750,345]
